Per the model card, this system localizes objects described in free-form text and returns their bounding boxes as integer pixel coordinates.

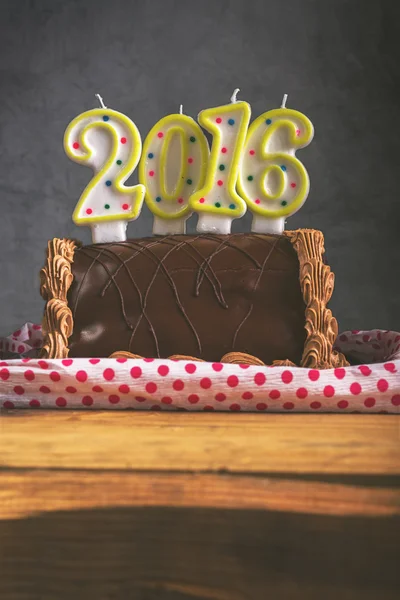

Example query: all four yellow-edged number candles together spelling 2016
[64,90,314,243]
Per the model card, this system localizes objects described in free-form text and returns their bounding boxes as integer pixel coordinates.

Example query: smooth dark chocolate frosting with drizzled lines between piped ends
[68,234,307,364]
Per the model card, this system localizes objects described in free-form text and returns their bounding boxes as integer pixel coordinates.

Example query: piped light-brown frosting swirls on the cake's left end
[40,238,78,358]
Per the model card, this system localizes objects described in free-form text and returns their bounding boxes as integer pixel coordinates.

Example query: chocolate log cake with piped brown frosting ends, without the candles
[41,230,347,368]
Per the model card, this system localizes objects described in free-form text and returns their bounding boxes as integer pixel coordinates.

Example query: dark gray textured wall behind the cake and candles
[0,0,400,335]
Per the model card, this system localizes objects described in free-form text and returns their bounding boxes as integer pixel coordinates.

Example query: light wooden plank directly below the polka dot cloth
[0,410,400,475]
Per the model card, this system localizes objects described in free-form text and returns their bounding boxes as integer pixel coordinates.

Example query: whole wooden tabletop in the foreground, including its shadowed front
[0,410,400,600]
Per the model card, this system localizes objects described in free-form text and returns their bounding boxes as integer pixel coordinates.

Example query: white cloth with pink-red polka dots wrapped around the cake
[0,324,400,413]
